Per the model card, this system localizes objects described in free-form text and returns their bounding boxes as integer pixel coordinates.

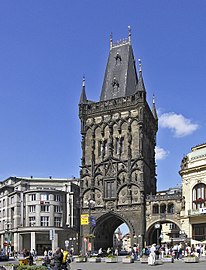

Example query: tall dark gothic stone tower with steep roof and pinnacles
[79,29,158,250]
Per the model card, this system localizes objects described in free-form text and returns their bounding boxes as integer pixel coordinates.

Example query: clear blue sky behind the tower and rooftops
[0,0,206,190]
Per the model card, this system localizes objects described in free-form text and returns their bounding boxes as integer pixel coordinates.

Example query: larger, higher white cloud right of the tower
[159,112,199,137]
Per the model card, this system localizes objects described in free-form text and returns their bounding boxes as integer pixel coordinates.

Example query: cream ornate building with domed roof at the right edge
[180,144,206,243]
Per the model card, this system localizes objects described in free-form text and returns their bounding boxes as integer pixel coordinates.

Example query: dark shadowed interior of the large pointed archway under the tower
[94,213,126,250]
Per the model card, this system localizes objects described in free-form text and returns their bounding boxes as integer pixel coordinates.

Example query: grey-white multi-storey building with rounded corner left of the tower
[0,177,79,255]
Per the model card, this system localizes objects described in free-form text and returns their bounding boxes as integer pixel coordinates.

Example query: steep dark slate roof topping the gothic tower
[100,39,138,101]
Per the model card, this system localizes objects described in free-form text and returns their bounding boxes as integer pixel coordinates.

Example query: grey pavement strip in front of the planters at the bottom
[71,261,206,270]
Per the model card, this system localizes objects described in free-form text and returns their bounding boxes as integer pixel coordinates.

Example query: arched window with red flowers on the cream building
[192,183,206,209]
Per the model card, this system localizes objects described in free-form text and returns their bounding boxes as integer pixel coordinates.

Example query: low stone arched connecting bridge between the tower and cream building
[146,187,184,245]
